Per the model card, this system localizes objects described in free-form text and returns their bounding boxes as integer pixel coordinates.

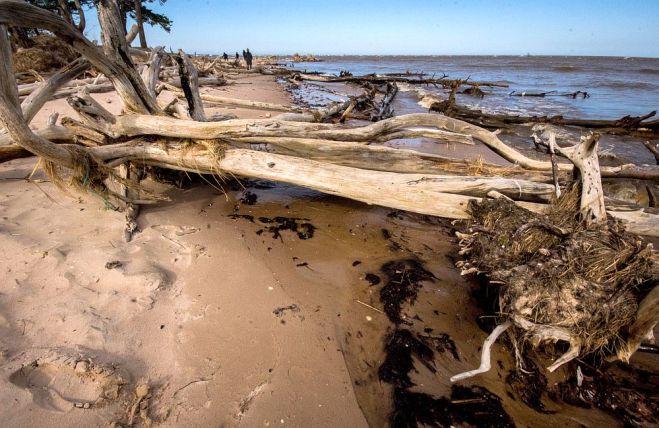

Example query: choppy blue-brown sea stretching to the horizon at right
[287,56,659,119]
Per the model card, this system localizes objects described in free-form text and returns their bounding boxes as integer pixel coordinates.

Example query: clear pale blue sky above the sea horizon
[89,0,659,57]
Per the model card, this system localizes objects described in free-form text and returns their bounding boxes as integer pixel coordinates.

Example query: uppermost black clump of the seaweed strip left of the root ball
[380,259,436,324]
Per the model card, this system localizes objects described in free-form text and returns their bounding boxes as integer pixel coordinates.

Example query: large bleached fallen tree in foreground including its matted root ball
[0,0,659,377]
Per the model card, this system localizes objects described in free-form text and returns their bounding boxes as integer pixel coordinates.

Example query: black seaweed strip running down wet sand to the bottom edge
[378,259,515,428]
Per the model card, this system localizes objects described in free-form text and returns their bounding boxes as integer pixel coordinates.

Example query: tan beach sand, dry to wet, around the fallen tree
[0,75,656,427]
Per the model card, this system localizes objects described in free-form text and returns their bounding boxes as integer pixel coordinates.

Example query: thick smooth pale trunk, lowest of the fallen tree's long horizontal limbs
[90,142,659,236]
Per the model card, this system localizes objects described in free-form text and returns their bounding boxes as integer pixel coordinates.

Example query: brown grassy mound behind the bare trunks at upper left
[13,35,80,73]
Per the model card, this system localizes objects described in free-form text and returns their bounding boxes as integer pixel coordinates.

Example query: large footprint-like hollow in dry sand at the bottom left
[9,355,126,412]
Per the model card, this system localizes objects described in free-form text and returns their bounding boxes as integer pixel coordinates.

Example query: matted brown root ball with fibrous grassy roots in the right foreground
[459,189,659,362]
